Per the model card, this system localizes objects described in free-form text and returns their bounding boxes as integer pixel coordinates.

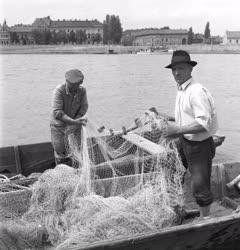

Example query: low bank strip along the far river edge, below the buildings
[0,44,240,54]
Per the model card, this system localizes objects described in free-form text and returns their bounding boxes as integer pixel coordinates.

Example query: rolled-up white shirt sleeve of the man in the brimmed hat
[190,88,213,131]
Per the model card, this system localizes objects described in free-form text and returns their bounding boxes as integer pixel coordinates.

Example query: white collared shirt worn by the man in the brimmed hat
[175,78,218,141]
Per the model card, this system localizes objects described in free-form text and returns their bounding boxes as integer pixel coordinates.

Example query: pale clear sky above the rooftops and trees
[0,0,240,36]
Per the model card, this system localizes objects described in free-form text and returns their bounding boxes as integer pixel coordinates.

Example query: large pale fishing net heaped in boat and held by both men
[0,111,184,249]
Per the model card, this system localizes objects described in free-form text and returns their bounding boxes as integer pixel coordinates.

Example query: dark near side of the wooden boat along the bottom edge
[58,214,240,250]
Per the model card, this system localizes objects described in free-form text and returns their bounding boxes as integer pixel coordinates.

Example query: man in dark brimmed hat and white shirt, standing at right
[158,50,218,217]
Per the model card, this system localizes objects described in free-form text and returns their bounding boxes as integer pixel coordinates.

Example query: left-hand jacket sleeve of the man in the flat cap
[52,88,64,120]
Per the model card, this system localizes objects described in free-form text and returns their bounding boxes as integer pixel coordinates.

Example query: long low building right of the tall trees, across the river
[124,28,188,47]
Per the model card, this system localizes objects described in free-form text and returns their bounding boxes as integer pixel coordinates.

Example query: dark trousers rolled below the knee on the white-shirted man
[179,136,215,207]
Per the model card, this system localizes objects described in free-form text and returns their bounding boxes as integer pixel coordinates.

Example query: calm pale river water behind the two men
[0,54,240,162]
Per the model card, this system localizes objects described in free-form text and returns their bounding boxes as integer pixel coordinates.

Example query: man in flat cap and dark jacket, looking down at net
[50,69,88,164]
